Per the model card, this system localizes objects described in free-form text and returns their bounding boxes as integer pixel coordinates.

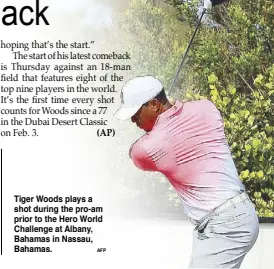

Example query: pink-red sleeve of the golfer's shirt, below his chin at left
[129,139,157,171]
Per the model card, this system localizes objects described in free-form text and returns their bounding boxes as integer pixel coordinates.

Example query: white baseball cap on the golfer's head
[114,76,163,120]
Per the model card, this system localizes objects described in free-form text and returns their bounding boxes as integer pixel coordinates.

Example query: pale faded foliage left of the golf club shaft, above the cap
[110,0,187,88]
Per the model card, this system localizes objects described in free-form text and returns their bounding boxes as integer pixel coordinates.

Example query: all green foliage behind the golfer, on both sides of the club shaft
[112,0,274,217]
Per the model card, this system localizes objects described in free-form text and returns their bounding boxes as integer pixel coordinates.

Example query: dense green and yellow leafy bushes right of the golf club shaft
[173,0,274,217]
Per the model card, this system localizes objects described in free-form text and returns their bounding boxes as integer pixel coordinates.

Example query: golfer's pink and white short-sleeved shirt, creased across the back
[130,100,245,221]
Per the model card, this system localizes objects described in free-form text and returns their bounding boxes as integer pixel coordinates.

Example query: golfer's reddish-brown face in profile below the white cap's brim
[131,101,161,132]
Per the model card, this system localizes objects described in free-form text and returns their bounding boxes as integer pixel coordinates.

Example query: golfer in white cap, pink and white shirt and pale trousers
[115,76,259,268]
